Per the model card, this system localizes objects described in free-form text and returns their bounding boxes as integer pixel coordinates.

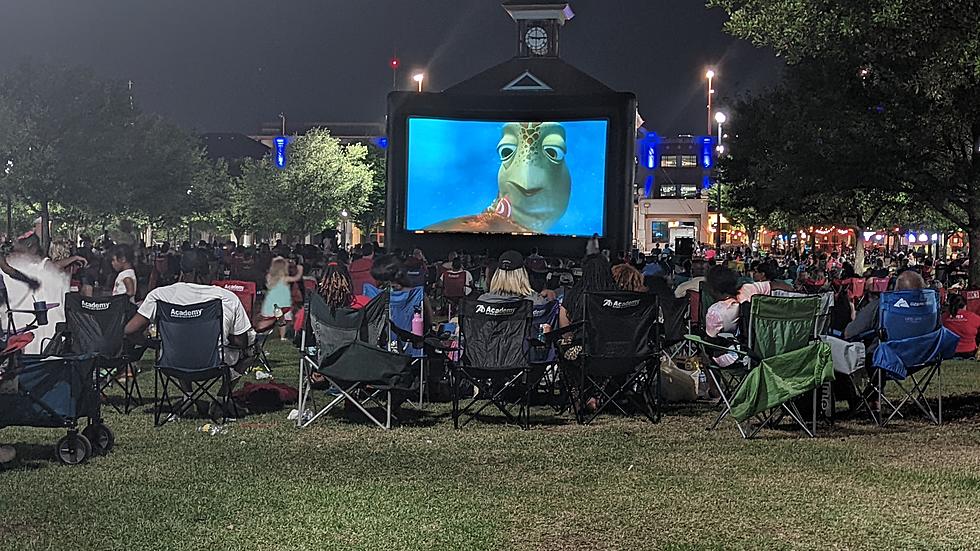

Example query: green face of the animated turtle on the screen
[497,122,572,232]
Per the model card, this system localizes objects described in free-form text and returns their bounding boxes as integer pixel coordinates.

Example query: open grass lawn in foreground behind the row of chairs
[0,342,980,550]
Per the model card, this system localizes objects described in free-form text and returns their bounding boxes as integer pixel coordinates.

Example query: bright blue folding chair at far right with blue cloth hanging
[872,289,959,426]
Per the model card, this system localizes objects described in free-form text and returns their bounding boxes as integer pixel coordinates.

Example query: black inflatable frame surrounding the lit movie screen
[385,92,636,256]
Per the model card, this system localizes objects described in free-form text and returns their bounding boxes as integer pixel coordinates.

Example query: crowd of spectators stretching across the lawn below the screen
[0,226,980,459]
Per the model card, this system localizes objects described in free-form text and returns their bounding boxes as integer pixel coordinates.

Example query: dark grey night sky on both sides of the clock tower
[0,0,781,135]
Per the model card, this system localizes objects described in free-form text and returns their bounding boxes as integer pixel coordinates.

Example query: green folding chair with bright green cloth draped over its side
[687,295,833,438]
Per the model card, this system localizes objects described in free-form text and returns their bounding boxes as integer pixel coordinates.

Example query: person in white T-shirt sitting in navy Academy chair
[126,249,255,413]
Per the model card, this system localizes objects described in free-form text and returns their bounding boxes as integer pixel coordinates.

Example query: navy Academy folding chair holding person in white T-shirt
[153,299,238,426]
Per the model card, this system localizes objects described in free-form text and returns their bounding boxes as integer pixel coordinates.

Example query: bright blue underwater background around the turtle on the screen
[406,117,608,236]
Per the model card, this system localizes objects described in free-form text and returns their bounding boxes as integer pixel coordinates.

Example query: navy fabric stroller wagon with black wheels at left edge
[0,296,115,465]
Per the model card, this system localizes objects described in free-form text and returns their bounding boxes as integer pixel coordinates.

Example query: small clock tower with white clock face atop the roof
[503,0,575,58]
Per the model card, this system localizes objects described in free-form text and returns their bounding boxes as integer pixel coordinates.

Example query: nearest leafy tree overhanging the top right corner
[708,0,980,286]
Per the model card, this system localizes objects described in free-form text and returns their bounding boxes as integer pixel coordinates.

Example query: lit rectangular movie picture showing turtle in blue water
[405,117,608,236]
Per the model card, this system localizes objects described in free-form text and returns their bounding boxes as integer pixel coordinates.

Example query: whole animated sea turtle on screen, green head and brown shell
[426,122,572,233]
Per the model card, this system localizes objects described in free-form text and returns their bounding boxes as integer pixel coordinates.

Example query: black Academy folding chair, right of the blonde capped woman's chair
[565,291,660,424]
